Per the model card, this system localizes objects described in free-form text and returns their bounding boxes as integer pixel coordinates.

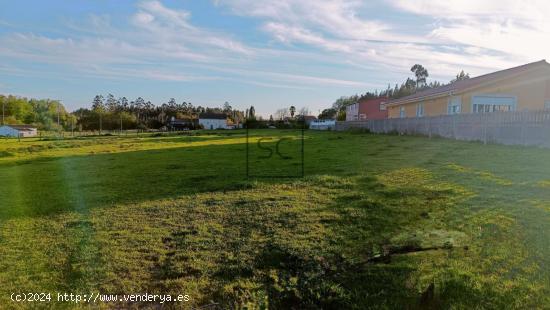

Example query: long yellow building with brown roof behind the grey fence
[386,60,550,118]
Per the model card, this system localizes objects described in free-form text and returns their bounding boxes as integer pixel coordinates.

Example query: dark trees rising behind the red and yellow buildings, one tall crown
[319,64,470,120]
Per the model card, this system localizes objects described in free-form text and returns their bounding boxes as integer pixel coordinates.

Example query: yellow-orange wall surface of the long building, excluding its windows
[388,68,550,118]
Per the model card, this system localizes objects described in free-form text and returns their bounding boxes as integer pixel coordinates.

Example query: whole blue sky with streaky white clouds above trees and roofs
[0,0,550,116]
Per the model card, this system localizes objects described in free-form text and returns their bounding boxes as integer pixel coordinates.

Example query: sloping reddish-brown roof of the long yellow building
[386,59,550,106]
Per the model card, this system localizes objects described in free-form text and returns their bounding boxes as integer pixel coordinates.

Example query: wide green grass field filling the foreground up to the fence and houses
[0,130,550,309]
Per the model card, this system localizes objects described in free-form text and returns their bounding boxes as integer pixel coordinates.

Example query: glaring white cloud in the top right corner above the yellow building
[392,0,550,63]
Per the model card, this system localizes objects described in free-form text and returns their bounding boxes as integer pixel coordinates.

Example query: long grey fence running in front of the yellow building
[336,110,550,147]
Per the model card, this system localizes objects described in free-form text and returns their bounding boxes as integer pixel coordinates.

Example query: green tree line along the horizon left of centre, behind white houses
[0,94,250,131]
